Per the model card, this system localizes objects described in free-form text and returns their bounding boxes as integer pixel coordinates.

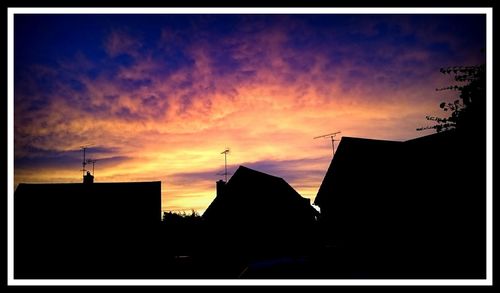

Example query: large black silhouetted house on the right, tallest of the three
[315,131,486,278]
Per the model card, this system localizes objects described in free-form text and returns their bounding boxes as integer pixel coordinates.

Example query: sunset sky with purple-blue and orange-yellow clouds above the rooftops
[14,14,486,213]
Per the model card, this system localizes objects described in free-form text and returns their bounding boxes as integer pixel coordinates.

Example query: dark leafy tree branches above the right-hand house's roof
[417,64,486,132]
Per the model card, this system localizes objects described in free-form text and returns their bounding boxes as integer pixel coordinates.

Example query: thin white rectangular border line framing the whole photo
[7,7,493,286]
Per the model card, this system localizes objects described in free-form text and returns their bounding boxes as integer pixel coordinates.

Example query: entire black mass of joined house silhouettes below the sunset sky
[15,119,486,279]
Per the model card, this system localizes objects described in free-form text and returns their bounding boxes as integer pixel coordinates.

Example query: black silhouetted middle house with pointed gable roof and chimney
[203,166,318,253]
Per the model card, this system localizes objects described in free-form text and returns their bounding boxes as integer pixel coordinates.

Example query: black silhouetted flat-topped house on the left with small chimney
[14,181,161,278]
